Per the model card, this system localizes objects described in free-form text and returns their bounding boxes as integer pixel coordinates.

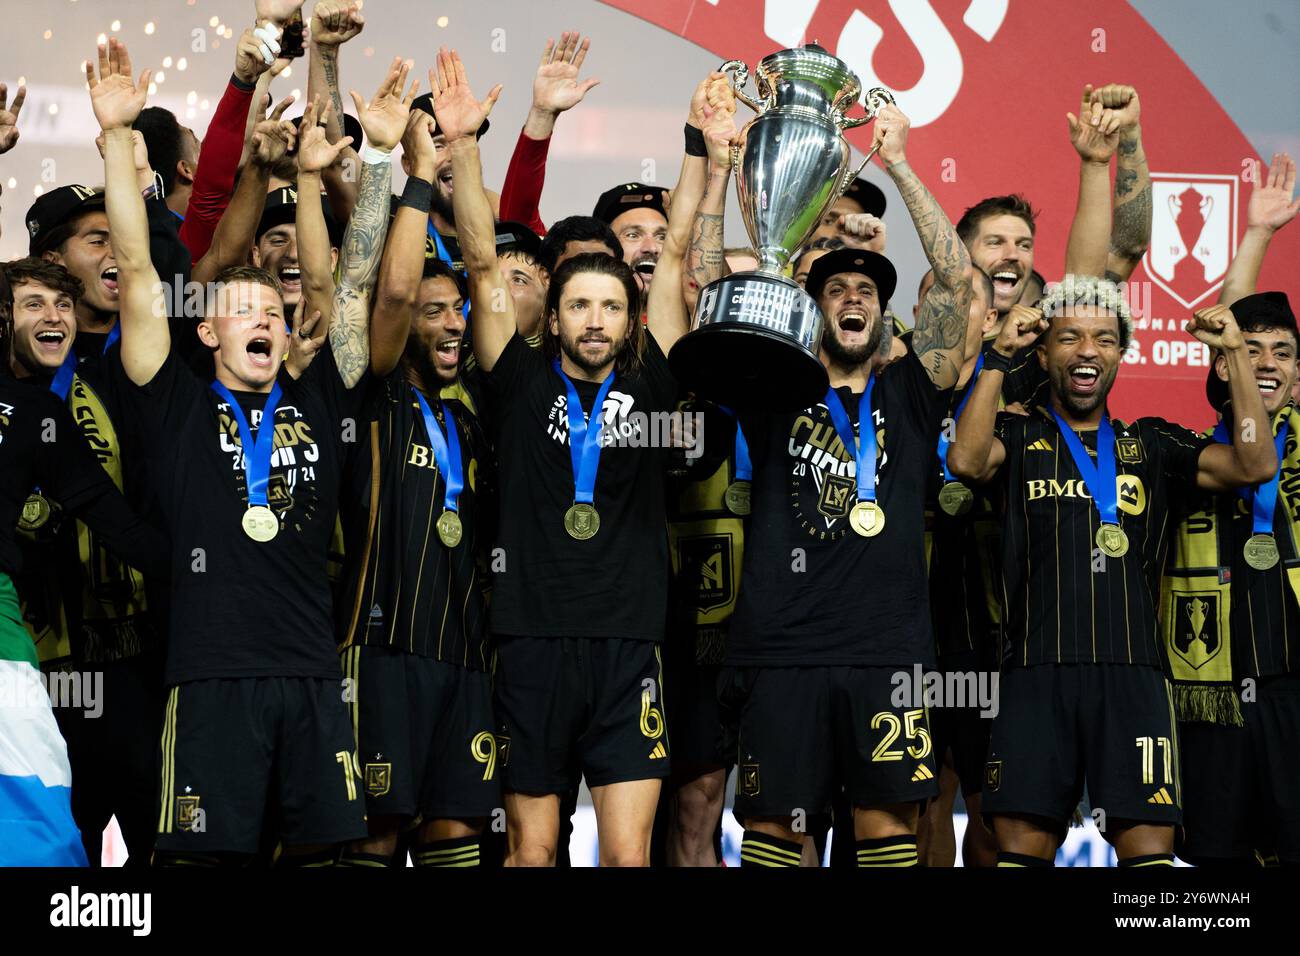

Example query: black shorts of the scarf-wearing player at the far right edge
[1178,674,1300,865]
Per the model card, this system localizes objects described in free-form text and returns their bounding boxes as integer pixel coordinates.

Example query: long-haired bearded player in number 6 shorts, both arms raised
[430,51,703,866]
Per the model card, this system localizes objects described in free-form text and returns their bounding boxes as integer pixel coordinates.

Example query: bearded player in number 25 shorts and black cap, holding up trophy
[719,107,971,866]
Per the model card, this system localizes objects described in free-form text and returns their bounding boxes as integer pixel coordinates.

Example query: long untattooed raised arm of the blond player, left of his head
[86,38,172,385]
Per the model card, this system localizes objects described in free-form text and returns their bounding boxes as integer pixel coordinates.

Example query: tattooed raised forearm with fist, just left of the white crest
[1092,83,1151,282]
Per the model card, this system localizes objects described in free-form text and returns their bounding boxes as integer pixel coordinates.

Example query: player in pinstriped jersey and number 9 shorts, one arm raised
[330,104,501,866]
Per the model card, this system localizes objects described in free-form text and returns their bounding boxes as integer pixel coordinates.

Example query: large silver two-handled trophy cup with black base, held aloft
[670,44,893,411]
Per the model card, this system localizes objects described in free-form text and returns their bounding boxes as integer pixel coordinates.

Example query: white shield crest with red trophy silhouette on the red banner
[1143,173,1238,308]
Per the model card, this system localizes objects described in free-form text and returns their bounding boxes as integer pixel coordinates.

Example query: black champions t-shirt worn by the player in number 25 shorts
[727,351,949,667]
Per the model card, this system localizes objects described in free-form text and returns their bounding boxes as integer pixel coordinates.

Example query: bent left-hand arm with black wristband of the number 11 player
[948,304,1048,483]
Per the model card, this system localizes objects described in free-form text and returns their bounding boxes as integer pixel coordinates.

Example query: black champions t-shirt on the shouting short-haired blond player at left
[124,347,364,684]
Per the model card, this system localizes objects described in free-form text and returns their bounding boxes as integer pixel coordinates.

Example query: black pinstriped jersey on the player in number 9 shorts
[335,367,497,670]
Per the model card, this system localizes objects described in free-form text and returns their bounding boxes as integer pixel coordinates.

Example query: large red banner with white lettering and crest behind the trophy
[605,0,1300,428]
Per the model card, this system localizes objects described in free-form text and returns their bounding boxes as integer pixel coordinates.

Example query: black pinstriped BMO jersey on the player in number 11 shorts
[995,407,1209,667]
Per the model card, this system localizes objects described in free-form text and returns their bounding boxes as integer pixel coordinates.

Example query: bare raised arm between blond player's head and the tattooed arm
[294,101,351,332]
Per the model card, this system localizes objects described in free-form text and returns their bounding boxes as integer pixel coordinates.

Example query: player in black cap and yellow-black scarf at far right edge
[1161,153,1300,866]
